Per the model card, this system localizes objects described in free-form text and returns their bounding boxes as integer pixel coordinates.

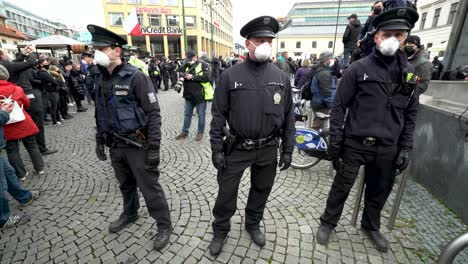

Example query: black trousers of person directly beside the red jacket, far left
[26,89,47,153]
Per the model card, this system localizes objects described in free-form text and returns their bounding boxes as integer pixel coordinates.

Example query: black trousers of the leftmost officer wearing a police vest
[110,143,171,229]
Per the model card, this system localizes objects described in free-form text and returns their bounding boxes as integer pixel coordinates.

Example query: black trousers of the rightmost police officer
[320,139,398,230]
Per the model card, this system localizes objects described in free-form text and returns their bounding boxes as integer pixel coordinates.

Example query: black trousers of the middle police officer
[212,145,277,238]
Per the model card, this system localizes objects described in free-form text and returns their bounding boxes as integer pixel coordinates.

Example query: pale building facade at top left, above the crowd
[0,0,74,39]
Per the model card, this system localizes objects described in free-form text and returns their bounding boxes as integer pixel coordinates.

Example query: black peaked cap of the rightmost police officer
[372,7,419,30]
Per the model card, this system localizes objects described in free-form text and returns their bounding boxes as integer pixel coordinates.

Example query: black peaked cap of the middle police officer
[240,16,279,39]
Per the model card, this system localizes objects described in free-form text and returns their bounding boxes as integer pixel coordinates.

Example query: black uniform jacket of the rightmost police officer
[330,50,419,149]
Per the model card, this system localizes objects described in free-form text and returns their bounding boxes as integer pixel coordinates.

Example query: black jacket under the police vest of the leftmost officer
[96,63,161,146]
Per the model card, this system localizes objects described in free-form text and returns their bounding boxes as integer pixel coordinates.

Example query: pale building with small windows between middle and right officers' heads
[273,0,374,59]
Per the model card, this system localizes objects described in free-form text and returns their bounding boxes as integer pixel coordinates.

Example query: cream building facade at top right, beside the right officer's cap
[411,0,458,59]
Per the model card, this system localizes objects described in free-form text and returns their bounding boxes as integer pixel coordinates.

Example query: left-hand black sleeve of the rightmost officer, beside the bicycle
[330,64,357,146]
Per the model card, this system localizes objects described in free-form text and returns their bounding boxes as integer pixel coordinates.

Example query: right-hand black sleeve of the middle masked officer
[281,75,296,153]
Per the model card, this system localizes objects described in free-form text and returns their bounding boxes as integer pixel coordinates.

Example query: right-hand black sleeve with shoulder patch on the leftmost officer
[131,71,161,146]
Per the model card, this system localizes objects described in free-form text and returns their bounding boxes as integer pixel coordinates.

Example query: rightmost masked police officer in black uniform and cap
[317,8,419,252]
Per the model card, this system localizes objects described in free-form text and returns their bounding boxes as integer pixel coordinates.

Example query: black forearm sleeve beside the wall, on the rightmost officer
[398,93,419,150]
